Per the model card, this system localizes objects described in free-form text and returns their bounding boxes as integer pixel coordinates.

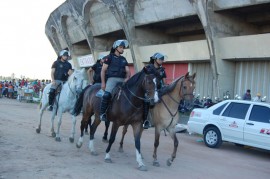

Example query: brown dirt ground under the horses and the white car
[0,98,270,179]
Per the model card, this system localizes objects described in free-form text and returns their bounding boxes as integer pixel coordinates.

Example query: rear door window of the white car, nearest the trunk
[222,102,250,119]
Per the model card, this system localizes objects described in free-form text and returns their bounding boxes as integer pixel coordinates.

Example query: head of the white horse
[68,69,85,95]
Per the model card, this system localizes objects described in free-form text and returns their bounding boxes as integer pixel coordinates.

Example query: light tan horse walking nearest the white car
[119,73,196,166]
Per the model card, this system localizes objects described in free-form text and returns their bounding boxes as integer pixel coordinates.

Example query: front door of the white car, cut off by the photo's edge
[244,105,270,149]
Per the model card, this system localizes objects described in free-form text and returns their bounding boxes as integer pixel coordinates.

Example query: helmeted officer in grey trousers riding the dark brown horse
[100,40,130,121]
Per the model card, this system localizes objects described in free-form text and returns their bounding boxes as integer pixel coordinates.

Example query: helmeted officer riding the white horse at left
[48,50,72,111]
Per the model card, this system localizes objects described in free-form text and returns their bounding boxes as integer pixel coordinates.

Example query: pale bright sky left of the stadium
[0,0,65,80]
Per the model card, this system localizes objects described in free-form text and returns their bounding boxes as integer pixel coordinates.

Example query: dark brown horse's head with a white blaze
[142,65,158,105]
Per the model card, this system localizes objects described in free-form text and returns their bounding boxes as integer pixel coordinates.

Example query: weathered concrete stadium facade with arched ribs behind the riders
[45,0,270,101]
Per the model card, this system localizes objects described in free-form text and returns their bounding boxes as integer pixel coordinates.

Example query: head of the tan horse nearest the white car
[180,72,196,110]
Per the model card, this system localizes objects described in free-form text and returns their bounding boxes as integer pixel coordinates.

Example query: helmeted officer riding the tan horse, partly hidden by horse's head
[143,53,167,129]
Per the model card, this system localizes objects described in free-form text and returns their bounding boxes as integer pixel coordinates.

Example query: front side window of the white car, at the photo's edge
[249,105,270,123]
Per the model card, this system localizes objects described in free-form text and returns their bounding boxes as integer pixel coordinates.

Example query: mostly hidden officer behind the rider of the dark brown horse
[87,55,106,84]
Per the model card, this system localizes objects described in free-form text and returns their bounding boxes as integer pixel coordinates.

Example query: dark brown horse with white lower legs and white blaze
[77,66,158,170]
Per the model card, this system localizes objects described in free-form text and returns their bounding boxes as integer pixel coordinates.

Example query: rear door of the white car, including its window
[218,102,250,142]
